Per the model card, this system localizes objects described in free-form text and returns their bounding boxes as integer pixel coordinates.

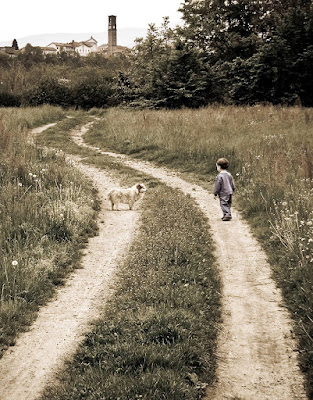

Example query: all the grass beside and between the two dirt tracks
[0,107,313,400]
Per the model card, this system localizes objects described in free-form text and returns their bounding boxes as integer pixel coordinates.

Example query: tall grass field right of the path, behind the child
[86,106,313,398]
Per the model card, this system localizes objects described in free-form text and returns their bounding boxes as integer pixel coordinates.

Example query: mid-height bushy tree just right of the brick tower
[127,18,210,108]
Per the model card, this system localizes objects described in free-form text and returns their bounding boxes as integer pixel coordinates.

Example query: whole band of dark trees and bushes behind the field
[0,0,313,108]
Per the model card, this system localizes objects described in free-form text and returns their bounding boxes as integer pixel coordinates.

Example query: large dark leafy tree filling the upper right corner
[179,0,313,104]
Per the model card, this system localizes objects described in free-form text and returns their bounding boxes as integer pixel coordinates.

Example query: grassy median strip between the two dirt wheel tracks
[43,184,220,400]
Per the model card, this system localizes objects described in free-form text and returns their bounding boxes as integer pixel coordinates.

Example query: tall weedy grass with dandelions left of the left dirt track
[0,107,97,353]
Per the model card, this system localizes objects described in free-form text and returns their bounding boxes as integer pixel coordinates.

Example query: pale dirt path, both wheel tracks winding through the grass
[0,124,306,400]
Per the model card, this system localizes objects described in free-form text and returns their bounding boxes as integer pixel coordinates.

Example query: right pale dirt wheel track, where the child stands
[73,125,306,400]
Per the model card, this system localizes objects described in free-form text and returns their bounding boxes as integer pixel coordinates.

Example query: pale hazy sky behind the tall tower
[0,0,182,41]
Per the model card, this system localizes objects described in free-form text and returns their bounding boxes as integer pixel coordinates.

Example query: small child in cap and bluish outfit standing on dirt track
[214,158,235,221]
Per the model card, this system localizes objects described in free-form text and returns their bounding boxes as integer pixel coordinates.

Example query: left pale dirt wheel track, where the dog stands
[0,124,139,400]
